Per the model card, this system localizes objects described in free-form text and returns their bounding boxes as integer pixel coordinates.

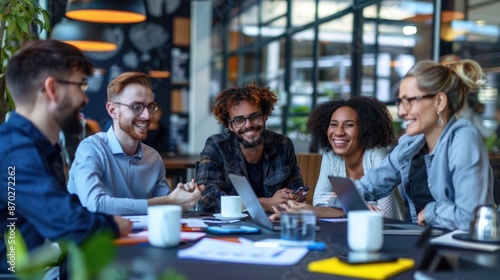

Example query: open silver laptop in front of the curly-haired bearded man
[228,174,281,230]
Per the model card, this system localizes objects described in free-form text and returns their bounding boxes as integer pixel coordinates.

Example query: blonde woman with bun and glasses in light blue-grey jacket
[356,60,493,230]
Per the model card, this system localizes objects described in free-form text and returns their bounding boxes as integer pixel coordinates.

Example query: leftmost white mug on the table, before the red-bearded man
[148,205,182,247]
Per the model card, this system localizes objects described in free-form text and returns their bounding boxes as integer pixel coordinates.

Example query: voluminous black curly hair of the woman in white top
[307,96,396,152]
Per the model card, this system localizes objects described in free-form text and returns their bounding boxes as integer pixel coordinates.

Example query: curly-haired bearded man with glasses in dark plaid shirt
[196,83,305,212]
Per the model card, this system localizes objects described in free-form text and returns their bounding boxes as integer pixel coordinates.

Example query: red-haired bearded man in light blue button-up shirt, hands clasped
[68,72,204,215]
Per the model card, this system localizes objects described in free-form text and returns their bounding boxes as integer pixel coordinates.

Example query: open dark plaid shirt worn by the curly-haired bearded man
[196,129,304,213]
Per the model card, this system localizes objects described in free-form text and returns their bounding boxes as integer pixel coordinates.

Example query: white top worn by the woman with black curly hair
[313,148,405,220]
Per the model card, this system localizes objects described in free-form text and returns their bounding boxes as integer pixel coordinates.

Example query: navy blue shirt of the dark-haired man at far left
[0,113,119,272]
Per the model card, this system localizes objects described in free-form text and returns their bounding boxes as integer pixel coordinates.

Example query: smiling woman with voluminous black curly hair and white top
[274,96,404,220]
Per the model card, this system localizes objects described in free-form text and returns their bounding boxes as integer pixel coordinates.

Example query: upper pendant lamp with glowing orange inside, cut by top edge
[66,0,146,24]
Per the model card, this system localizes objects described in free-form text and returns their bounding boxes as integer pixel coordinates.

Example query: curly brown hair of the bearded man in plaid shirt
[213,82,278,128]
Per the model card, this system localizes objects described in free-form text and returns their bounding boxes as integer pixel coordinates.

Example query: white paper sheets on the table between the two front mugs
[177,238,308,265]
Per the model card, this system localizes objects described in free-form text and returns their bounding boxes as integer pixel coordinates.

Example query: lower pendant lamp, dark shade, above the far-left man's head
[50,20,117,52]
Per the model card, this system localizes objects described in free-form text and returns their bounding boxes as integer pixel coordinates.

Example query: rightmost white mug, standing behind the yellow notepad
[347,210,384,252]
